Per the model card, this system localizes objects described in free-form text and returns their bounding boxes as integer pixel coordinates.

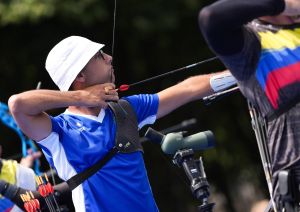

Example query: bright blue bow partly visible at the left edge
[0,102,40,175]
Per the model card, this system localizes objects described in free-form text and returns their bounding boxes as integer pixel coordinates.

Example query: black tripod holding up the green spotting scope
[173,149,215,212]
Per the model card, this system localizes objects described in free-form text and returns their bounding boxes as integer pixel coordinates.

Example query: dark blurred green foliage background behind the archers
[0,0,268,212]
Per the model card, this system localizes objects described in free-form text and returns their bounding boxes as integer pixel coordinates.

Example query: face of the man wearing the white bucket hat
[83,50,115,86]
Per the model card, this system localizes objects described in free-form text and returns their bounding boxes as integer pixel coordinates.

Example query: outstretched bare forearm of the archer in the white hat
[157,71,228,118]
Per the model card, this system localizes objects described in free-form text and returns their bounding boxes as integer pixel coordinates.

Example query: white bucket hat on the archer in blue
[46,36,104,91]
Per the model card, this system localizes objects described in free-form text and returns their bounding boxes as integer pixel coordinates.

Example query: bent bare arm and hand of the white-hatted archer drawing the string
[8,83,118,141]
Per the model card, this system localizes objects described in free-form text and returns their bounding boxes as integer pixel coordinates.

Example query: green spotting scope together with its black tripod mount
[145,128,215,212]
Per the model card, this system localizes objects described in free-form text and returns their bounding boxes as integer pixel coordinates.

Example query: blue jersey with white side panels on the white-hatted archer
[39,95,158,212]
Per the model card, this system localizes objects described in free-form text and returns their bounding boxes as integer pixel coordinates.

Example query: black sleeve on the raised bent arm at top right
[198,0,285,56]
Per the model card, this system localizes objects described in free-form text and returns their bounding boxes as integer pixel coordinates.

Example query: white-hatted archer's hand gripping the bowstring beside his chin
[81,83,119,108]
